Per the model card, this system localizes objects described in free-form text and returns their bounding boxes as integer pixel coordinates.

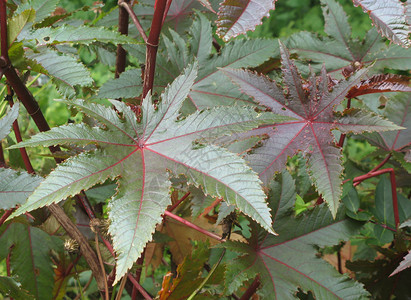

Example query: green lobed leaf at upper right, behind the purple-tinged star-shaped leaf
[286,0,411,76]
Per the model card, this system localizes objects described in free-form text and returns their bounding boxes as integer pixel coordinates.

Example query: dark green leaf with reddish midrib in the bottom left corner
[0,223,63,300]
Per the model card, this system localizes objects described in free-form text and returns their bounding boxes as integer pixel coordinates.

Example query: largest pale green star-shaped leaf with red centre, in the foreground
[8,65,290,282]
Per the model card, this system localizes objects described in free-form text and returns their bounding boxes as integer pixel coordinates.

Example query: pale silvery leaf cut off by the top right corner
[353,0,411,47]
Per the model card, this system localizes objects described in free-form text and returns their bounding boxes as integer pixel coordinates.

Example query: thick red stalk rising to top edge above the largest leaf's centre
[143,0,167,98]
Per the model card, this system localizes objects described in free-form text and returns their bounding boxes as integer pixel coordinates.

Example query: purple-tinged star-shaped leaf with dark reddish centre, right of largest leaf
[223,42,400,216]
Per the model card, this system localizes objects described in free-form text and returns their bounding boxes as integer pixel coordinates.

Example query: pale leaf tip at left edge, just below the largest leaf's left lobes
[0,168,43,210]
